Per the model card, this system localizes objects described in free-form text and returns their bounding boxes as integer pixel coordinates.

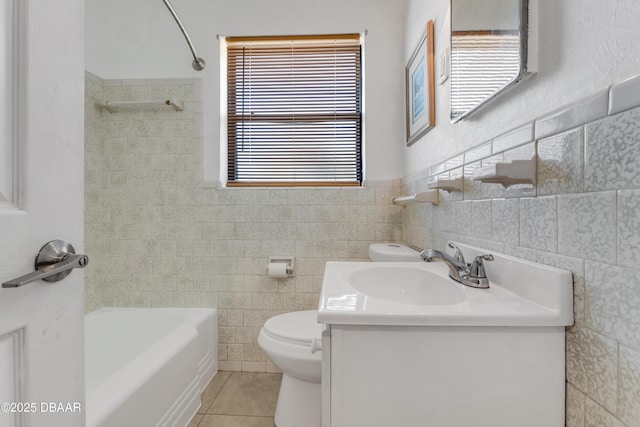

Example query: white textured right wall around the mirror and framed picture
[404,0,640,175]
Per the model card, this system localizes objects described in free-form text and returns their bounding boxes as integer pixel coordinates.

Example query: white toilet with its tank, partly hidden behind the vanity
[258,243,422,427]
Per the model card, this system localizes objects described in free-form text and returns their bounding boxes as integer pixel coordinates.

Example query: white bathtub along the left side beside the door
[85,308,218,427]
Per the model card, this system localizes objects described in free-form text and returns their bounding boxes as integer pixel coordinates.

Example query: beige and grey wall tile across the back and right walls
[85,74,640,427]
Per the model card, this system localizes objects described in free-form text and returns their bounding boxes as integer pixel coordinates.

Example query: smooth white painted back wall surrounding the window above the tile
[86,0,404,181]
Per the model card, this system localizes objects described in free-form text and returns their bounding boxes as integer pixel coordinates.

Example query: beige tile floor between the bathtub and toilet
[188,371,282,427]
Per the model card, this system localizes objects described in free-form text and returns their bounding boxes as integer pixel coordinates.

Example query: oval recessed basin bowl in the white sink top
[348,265,466,305]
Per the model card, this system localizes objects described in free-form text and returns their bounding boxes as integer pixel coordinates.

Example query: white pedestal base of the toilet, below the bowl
[274,374,322,427]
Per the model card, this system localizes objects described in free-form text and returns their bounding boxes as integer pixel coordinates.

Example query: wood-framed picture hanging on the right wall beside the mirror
[405,21,436,146]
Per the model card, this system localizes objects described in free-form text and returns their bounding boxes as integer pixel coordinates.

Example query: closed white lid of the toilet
[262,310,323,346]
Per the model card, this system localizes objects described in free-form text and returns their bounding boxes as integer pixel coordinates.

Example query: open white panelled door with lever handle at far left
[0,0,84,427]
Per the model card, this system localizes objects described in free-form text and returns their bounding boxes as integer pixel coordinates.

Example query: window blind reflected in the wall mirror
[451,31,520,117]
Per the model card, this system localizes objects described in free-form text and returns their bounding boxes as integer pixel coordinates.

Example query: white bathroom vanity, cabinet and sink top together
[318,245,573,427]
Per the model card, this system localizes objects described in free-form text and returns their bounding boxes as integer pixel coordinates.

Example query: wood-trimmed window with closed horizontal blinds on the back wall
[226,34,362,186]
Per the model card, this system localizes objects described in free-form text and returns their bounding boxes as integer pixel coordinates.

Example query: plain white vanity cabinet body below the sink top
[322,325,565,427]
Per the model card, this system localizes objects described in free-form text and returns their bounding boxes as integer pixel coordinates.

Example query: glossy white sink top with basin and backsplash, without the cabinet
[318,244,573,326]
